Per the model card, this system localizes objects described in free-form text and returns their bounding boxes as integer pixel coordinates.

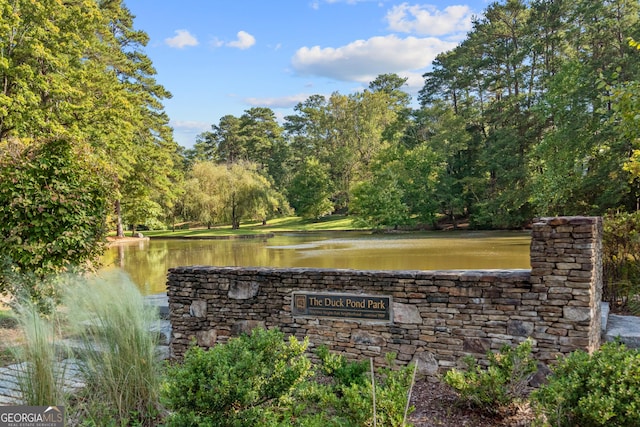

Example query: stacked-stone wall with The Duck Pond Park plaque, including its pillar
[167,217,602,374]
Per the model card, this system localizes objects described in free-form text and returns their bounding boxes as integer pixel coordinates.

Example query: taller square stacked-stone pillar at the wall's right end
[531,217,602,359]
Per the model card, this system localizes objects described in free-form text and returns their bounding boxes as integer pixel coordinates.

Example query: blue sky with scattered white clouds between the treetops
[124,0,488,147]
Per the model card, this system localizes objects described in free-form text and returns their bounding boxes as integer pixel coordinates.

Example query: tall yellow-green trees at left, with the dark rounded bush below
[0,0,180,297]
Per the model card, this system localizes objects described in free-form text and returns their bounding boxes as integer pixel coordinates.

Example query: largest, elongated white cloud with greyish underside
[291,35,456,83]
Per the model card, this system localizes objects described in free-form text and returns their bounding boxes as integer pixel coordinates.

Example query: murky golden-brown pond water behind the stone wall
[102,231,531,295]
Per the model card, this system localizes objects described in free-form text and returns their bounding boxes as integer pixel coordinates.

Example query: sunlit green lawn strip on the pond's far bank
[142,215,364,237]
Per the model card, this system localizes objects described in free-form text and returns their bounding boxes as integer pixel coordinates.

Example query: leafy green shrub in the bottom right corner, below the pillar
[531,343,640,427]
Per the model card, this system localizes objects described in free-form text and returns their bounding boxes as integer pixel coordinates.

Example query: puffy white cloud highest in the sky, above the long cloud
[386,3,473,36]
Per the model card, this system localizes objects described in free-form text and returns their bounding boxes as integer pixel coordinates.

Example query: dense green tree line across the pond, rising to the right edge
[181,0,640,228]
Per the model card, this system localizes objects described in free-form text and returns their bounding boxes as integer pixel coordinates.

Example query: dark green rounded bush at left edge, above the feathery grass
[0,139,111,301]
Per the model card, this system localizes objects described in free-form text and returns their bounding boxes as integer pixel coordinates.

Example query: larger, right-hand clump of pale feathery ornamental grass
[64,276,161,425]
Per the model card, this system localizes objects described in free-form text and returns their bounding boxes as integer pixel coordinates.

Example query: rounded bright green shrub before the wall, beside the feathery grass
[163,329,311,426]
